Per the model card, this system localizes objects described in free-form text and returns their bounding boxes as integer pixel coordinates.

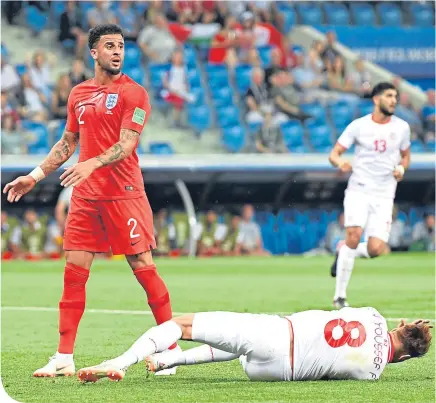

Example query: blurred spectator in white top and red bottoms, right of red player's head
[161,50,195,127]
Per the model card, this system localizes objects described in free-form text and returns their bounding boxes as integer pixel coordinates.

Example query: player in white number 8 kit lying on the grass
[78,307,433,382]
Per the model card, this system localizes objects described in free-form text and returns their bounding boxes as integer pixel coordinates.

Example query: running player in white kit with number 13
[329,83,410,308]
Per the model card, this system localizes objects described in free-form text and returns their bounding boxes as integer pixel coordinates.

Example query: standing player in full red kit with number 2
[3,24,176,377]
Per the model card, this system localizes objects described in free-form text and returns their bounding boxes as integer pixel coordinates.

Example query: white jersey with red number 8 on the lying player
[287,308,391,381]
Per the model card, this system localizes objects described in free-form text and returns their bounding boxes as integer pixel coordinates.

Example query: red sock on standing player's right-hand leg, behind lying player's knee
[133,264,177,350]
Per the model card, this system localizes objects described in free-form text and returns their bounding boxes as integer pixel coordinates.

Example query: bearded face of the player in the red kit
[91,34,124,76]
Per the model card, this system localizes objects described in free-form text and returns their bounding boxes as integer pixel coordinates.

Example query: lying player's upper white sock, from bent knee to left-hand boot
[111,320,182,368]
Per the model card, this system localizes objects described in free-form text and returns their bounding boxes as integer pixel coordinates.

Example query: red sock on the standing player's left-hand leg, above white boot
[58,263,89,354]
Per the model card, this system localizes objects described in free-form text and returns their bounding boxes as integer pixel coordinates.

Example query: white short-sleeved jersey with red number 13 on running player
[338,115,410,198]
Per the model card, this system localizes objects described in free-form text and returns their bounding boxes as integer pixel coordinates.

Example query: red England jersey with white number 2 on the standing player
[65,74,151,200]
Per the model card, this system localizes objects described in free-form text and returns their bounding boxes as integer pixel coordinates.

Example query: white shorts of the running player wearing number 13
[344,190,394,242]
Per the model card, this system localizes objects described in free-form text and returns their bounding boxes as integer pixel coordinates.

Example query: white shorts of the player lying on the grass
[192,312,292,381]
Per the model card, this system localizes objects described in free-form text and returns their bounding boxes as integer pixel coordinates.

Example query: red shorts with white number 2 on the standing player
[64,194,156,255]
